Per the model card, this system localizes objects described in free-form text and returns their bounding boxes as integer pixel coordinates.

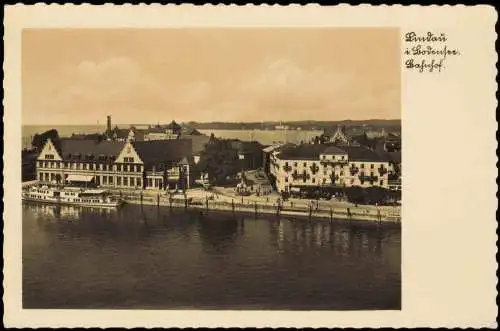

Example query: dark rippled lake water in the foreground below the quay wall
[22,204,401,310]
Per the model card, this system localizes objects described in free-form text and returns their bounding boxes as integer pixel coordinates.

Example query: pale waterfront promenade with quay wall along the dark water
[23,182,401,223]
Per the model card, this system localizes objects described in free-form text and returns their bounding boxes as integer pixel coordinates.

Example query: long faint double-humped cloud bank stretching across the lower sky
[26,57,399,123]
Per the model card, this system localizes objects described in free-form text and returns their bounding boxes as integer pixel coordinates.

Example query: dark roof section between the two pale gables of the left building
[56,138,125,160]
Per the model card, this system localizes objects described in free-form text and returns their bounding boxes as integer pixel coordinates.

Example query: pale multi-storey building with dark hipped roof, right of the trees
[269,144,389,193]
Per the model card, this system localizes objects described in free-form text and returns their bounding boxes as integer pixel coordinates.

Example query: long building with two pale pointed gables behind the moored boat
[36,139,194,190]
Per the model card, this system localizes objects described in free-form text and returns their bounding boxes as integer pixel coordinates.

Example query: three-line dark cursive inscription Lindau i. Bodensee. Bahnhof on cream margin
[404,32,460,73]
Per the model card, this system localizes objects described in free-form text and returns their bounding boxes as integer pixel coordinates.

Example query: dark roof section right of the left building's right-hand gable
[132,139,192,169]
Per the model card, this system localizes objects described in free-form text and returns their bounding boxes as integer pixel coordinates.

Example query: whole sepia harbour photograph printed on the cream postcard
[21,28,402,310]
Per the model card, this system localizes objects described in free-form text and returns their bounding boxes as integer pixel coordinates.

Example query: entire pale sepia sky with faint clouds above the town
[22,28,401,125]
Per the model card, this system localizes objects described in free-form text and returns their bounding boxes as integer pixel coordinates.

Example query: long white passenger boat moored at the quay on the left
[22,185,123,207]
